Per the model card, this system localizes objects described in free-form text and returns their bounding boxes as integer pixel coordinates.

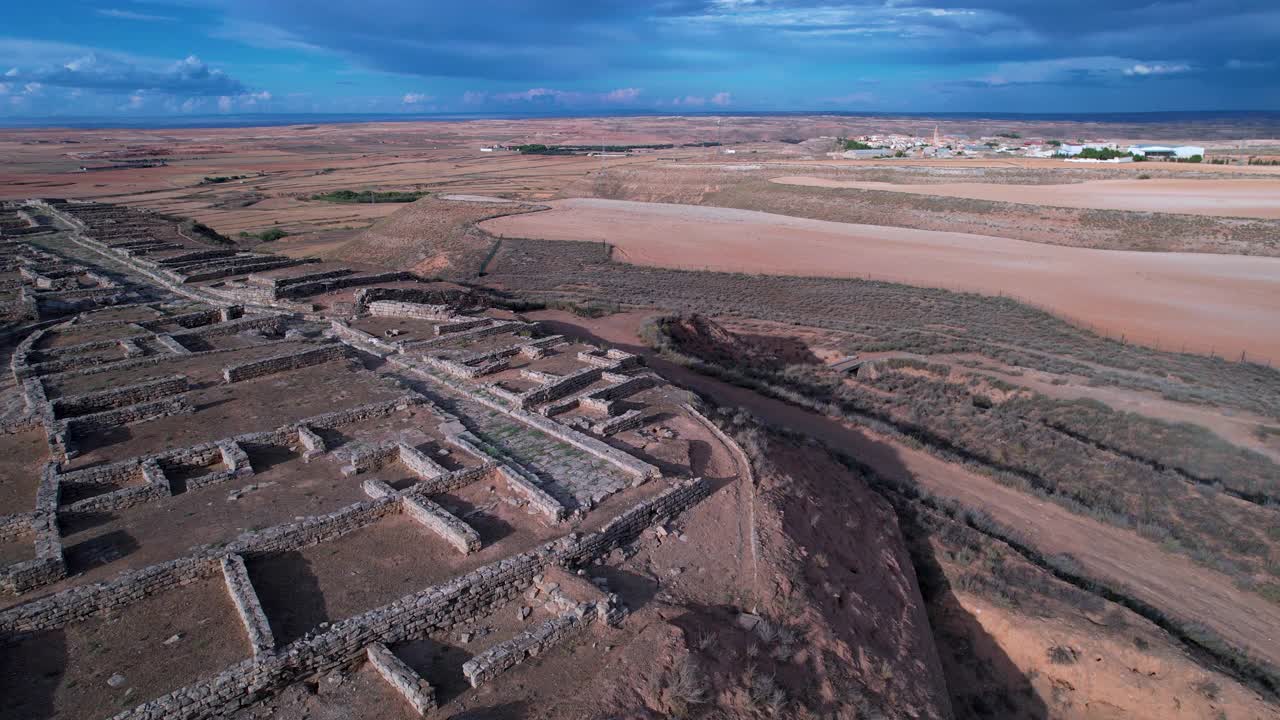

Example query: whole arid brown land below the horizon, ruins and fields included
[0,115,1280,720]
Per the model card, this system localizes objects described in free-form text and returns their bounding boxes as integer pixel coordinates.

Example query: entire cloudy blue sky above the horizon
[0,0,1280,118]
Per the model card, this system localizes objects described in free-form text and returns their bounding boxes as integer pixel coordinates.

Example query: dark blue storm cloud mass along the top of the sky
[207,0,1280,81]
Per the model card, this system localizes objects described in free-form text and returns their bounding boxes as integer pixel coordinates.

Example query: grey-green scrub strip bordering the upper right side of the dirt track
[634,318,1280,585]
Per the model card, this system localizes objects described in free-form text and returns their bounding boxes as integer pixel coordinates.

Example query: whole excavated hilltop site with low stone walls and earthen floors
[0,201,741,719]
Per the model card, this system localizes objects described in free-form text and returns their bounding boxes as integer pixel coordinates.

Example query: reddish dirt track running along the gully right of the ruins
[531,311,1280,665]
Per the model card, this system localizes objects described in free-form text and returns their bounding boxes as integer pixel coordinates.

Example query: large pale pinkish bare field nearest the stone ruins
[483,199,1280,361]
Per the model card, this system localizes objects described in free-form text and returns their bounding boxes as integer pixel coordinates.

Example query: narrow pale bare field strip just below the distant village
[769,176,1280,220]
